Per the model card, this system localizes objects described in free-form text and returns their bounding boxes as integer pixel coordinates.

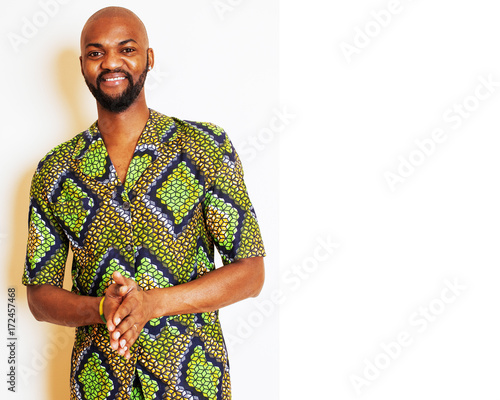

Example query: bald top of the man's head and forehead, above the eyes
[80,7,149,54]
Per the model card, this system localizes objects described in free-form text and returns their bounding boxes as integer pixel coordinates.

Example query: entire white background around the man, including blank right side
[0,0,500,400]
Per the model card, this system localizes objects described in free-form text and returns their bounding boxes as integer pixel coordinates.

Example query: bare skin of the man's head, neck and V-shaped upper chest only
[80,8,154,182]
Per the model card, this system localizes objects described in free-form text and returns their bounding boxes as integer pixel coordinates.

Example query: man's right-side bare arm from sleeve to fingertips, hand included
[106,257,264,358]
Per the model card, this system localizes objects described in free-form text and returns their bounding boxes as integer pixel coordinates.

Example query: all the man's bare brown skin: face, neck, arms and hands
[27,7,264,359]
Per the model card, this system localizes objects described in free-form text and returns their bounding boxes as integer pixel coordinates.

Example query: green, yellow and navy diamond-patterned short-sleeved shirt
[23,110,265,400]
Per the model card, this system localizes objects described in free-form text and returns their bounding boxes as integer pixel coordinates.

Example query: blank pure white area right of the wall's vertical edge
[280,0,500,400]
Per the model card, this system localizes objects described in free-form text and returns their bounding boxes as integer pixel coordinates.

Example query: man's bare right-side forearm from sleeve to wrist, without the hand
[145,257,264,318]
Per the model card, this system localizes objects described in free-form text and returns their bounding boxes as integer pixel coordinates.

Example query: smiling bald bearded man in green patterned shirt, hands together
[23,7,265,399]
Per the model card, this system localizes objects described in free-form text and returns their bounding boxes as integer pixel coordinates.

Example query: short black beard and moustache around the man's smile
[84,61,149,113]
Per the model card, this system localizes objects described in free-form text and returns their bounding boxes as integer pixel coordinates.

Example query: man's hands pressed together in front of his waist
[103,271,151,360]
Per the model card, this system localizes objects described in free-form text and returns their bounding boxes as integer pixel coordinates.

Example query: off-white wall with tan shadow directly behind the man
[0,0,280,400]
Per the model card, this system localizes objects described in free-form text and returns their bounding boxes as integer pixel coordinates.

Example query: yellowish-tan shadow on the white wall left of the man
[11,48,93,400]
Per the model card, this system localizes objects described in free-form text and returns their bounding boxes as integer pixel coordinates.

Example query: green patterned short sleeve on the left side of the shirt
[22,168,69,287]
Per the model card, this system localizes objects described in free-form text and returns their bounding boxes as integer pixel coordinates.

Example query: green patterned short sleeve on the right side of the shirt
[204,132,266,264]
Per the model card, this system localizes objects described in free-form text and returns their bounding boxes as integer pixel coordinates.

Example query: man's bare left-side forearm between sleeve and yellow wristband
[27,285,102,327]
